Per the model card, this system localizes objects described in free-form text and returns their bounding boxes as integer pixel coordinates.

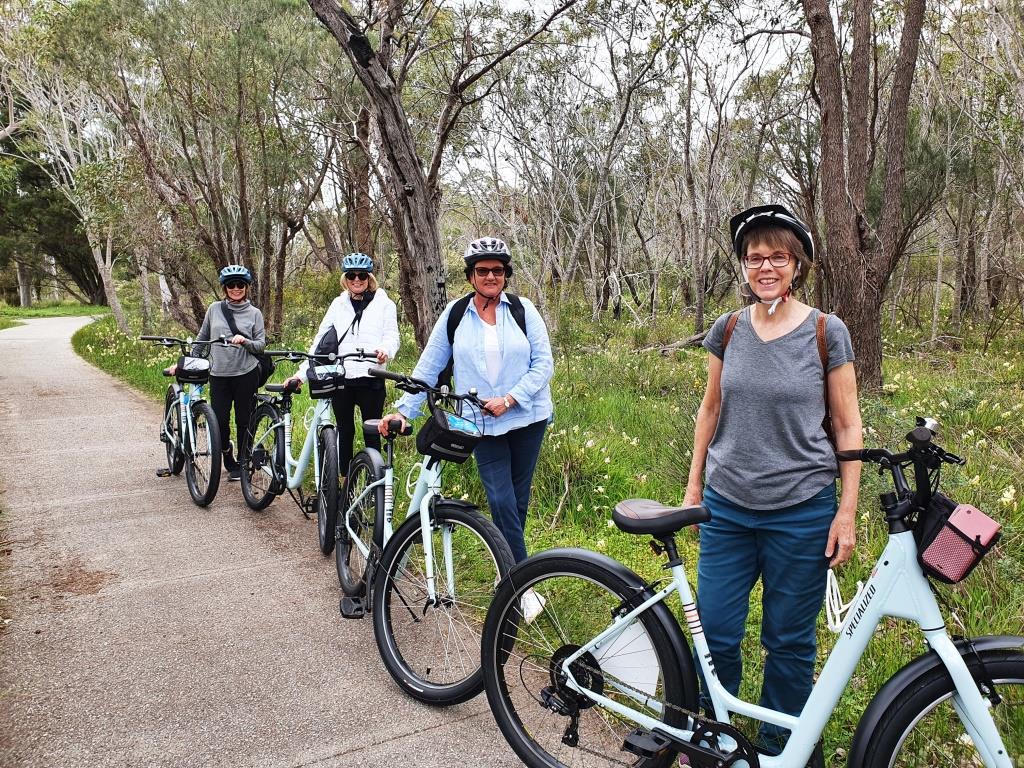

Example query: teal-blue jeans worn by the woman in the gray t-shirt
[697,483,836,754]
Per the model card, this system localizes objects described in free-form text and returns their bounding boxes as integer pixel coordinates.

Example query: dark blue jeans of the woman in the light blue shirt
[473,420,548,562]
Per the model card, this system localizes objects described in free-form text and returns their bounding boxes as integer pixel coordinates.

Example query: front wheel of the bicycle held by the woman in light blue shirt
[373,504,513,706]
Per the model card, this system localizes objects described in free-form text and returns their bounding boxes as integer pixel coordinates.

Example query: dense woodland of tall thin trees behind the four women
[0,0,1024,389]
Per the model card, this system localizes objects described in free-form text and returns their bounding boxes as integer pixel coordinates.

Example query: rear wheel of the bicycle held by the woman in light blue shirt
[334,450,384,597]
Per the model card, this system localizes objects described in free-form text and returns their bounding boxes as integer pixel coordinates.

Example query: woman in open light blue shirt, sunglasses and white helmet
[381,238,554,612]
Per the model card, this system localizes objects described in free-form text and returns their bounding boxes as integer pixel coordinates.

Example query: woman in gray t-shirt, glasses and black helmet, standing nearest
[684,205,862,755]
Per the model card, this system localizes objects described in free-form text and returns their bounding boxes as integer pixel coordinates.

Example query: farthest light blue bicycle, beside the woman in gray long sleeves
[139,336,224,507]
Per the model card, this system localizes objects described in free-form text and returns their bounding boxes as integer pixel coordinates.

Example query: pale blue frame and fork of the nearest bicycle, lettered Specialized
[562,531,1014,768]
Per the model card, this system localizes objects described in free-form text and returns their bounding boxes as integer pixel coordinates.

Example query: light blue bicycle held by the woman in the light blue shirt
[335,368,514,706]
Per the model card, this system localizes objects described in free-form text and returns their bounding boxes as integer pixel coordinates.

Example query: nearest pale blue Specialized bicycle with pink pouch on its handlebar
[482,420,1024,768]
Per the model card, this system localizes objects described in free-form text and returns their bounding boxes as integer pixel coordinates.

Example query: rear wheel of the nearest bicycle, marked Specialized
[481,553,697,768]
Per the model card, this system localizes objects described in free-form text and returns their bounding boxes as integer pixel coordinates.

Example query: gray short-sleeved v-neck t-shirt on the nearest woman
[703,308,853,510]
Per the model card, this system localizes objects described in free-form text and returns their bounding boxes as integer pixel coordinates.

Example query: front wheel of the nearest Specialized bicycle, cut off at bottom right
[851,649,1024,768]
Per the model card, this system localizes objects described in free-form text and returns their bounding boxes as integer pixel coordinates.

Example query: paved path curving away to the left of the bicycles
[0,317,519,768]
